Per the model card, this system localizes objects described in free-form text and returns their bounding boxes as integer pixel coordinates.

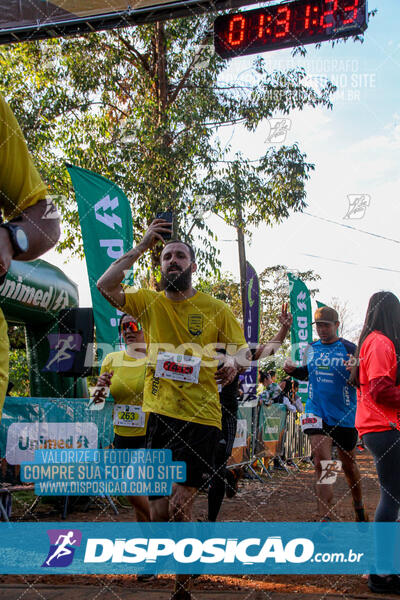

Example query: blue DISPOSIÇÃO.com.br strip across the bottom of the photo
[0,522,400,574]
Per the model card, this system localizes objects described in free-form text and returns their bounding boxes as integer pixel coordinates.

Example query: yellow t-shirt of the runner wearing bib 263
[100,350,149,437]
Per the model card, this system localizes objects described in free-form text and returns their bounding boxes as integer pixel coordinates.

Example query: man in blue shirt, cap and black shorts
[284,306,367,521]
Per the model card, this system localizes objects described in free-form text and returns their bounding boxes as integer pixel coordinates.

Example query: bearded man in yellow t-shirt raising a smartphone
[97,219,249,600]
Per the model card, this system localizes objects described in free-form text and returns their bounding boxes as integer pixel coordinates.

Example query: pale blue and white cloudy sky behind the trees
[43,0,400,338]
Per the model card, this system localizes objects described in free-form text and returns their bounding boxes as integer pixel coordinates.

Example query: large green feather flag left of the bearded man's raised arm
[67,165,133,360]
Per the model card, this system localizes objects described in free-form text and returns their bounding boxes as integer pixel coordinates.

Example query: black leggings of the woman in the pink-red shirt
[363,429,400,523]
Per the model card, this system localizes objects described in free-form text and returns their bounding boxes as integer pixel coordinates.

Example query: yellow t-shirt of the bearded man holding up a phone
[123,287,247,428]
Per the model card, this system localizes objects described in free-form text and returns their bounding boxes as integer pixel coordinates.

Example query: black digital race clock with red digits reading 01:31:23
[214,0,368,58]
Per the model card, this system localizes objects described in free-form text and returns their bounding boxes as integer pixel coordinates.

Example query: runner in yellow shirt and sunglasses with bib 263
[97,314,150,521]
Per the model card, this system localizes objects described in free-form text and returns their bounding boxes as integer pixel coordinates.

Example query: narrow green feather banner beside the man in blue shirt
[288,273,312,402]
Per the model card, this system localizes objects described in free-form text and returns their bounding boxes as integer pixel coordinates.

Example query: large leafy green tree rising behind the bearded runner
[0,17,335,271]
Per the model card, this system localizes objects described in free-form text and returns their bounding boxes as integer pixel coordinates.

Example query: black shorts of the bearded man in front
[146,413,220,500]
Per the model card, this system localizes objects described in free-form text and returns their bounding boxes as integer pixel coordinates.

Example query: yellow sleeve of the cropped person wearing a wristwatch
[0,95,47,220]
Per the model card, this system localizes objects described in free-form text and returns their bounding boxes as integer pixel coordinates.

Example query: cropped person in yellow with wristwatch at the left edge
[0,95,60,418]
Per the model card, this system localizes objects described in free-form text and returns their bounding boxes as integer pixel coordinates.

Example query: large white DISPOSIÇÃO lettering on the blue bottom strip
[84,536,314,565]
